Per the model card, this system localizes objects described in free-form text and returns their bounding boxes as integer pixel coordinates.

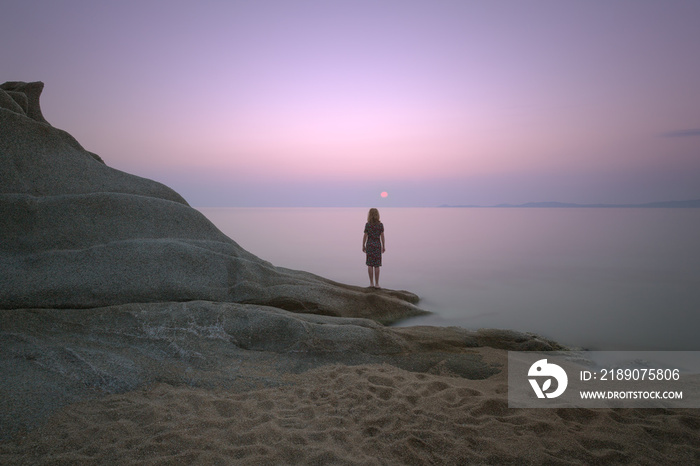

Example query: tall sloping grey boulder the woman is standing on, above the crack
[0,82,423,322]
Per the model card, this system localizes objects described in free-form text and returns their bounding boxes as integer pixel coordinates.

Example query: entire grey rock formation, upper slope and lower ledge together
[0,83,556,440]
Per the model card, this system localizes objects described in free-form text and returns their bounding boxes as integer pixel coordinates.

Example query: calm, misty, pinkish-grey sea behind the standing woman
[199,208,700,350]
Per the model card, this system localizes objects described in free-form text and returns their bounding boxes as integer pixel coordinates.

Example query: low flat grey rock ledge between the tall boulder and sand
[0,301,552,441]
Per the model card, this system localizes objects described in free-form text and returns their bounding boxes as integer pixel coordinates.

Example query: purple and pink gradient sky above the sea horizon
[5,0,700,207]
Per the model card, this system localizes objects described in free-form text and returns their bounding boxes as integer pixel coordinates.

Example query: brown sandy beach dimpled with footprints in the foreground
[0,348,700,465]
